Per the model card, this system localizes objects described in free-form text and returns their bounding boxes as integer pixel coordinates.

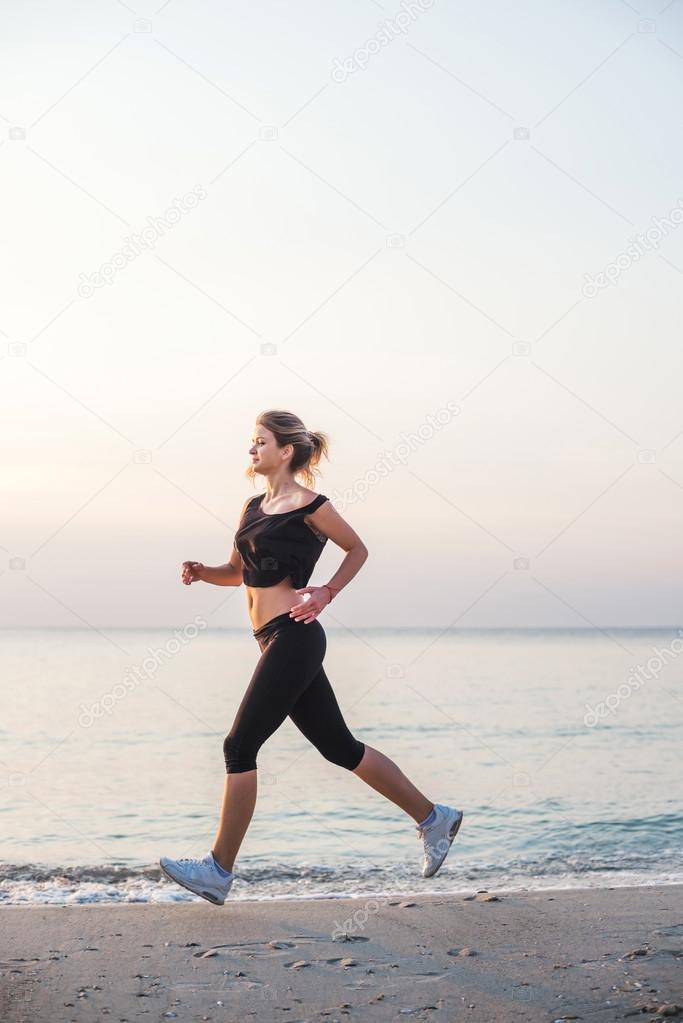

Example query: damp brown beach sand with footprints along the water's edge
[0,886,683,1023]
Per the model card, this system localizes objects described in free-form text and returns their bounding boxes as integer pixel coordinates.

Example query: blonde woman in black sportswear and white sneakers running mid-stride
[160,410,462,905]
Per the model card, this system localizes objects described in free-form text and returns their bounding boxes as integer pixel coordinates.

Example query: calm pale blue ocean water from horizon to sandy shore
[0,623,683,903]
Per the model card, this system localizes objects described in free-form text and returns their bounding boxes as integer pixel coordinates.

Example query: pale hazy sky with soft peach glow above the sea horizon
[0,0,683,629]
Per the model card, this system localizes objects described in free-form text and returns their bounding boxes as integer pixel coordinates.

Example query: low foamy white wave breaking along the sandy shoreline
[0,850,683,905]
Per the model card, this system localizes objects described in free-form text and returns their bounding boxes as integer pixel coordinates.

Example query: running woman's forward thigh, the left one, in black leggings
[230,622,326,745]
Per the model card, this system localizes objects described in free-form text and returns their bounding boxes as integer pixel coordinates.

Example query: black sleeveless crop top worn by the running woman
[233,494,328,589]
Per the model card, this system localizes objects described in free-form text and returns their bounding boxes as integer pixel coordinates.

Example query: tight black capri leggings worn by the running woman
[223,611,365,774]
